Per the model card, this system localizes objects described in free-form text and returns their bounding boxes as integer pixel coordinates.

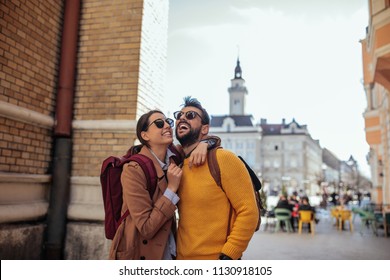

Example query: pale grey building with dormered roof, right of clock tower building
[260,119,322,196]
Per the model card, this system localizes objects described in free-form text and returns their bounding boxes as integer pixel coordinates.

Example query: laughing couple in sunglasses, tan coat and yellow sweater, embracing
[109,97,258,260]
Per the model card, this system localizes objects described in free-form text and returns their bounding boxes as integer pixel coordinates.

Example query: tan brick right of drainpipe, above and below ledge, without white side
[72,0,143,176]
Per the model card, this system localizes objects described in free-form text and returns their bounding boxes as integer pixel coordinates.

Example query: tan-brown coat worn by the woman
[109,147,176,260]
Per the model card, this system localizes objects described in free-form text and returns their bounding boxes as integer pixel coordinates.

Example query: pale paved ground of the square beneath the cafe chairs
[243,208,390,260]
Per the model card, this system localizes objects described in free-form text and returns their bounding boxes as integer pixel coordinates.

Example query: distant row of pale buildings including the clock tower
[210,59,370,201]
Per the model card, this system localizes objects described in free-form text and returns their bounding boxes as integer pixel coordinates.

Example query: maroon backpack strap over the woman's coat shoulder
[118,151,157,225]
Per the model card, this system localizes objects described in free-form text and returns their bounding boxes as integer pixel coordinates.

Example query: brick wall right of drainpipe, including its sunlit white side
[72,0,168,176]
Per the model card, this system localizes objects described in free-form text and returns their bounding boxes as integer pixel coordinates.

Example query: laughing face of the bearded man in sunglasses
[175,107,203,147]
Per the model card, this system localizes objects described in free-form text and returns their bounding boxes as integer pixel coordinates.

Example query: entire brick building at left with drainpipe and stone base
[0,0,169,259]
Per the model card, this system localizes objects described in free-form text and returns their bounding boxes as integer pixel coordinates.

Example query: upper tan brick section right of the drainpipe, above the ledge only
[75,0,143,120]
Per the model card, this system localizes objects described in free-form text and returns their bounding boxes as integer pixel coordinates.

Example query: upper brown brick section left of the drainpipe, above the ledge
[0,0,62,115]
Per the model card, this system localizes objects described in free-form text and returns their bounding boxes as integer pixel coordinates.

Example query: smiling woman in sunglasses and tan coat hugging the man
[109,110,207,260]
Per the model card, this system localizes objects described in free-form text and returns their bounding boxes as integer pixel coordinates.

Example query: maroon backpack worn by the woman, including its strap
[100,145,181,239]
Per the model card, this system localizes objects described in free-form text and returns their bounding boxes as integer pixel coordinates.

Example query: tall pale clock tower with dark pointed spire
[228,58,248,115]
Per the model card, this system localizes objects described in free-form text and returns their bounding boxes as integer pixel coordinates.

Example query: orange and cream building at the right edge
[361,0,390,204]
